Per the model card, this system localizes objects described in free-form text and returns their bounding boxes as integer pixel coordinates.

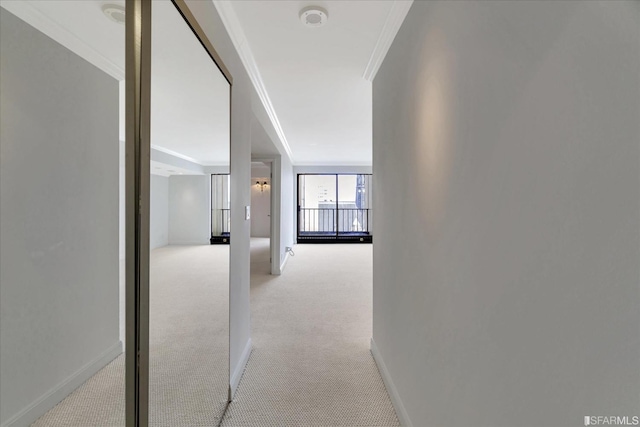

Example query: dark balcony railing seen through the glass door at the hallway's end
[299,207,370,234]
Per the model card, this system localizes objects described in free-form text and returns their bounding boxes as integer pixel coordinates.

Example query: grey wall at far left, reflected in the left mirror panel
[0,9,122,426]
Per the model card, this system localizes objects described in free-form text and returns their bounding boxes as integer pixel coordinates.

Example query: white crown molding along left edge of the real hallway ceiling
[213,0,293,162]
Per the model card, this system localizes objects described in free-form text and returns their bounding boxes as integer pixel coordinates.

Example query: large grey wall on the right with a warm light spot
[373,1,640,427]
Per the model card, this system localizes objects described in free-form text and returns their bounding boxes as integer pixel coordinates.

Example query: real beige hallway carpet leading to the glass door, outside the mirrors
[222,238,399,427]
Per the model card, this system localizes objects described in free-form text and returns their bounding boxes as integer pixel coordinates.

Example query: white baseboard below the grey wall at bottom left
[1,341,122,427]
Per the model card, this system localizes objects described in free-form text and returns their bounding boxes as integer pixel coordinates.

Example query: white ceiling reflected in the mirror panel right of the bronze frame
[151,1,231,166]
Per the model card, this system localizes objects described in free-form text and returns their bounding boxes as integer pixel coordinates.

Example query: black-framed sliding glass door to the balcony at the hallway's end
[297,174,373,243]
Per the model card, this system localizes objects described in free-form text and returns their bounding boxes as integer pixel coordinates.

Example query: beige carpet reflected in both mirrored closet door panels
[33,245,229,427]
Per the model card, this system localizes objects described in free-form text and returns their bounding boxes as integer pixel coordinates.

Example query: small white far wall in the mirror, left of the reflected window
[168,175,211,245]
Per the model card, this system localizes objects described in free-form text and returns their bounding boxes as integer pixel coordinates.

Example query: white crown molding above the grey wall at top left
[1,1,124,80]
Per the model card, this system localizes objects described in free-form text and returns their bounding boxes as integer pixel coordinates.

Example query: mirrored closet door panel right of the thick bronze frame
[148,1,230,426]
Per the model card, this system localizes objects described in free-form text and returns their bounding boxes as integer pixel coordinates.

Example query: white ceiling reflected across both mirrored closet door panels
[0,0,230,168]
